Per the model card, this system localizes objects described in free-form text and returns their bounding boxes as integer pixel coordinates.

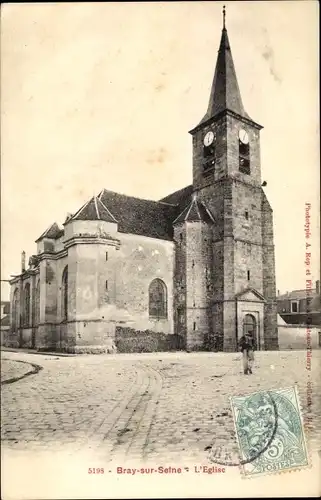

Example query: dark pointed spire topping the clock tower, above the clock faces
[194,5,252,129]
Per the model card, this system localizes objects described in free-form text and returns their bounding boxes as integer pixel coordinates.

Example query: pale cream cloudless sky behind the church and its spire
[1,0,320,299]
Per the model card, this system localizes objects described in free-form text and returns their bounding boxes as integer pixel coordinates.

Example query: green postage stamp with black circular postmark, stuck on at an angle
[231,387,309,476]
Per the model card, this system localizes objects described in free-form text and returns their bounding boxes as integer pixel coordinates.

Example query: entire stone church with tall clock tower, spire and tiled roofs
[10,12,278,353]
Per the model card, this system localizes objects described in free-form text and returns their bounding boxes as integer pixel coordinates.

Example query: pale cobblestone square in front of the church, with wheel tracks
[1,351,321,467]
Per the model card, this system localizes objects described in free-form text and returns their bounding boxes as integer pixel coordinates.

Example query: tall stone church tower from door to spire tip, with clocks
[190,7,278,351]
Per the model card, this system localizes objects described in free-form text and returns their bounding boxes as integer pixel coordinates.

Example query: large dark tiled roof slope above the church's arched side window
[99,189,178,240]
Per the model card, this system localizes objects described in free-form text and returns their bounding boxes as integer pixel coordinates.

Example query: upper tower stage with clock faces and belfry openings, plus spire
[190,7,263,190]
